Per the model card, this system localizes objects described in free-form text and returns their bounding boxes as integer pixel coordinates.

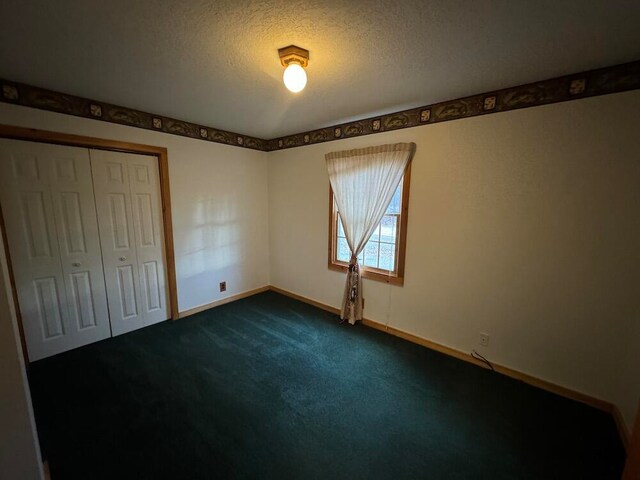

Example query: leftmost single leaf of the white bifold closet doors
[0,144,73,360]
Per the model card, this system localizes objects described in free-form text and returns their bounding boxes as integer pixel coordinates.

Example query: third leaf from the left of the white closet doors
[90,150,144,335]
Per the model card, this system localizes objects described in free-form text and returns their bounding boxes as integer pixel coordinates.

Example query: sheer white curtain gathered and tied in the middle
[325,143,416,325]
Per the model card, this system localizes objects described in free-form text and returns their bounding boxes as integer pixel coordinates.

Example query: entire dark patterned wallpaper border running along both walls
[0,61,640,152]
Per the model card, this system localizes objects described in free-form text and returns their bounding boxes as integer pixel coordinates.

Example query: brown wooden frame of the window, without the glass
[327,162,411,286]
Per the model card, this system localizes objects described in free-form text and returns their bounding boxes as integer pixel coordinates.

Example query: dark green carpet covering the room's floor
[30,292,623,480]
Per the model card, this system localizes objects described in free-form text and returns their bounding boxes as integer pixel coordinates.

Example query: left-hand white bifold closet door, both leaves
[0,140,111,361]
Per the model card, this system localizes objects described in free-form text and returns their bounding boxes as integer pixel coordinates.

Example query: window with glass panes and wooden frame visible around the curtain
[329,163,411,285]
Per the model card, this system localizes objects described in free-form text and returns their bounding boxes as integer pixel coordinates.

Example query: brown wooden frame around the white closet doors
[0,124,179,364]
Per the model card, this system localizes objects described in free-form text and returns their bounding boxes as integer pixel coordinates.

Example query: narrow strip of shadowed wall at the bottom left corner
[0,232,42,480]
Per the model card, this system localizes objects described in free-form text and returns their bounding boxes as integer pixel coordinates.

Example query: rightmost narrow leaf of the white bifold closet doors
[128,155,169,325]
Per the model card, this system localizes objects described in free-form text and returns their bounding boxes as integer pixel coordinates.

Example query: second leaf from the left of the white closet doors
[49,147,111,346]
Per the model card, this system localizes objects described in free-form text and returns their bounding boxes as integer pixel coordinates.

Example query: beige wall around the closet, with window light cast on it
[0,104,269,311]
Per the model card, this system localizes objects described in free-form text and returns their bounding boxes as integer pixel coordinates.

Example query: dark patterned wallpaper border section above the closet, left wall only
[0,79,267,151]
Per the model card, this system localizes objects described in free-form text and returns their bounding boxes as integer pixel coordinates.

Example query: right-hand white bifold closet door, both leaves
[90,150,169,335]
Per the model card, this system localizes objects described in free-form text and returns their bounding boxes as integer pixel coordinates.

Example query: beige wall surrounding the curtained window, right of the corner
[269,92,640,432]
